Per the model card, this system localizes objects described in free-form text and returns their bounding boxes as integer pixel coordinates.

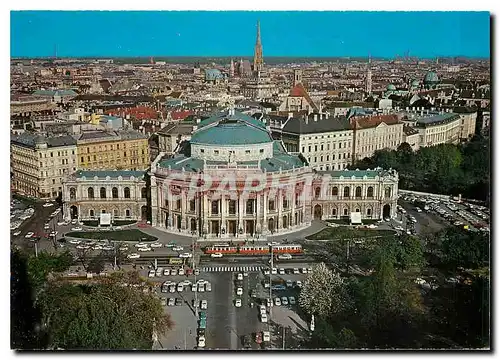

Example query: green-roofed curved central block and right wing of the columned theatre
[149,109,398,238]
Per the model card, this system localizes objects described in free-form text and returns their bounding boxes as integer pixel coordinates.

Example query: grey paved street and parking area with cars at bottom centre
[142,265,308,349]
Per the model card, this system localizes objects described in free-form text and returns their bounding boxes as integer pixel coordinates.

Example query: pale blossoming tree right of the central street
[299,263,345,316]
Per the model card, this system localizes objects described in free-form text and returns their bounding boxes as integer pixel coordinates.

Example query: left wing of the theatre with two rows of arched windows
[62,170,148,220]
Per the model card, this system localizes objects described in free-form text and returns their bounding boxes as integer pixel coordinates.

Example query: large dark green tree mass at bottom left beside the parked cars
[40,273,173,350]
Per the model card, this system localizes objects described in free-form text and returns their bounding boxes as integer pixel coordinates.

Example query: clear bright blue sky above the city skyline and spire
[10,11,490,59]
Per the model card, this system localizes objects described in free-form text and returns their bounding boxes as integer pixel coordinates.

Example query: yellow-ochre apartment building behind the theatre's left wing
[77,130,150,170]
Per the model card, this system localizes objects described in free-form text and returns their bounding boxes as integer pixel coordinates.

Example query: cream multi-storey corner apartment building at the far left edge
[11,132,77,199]
